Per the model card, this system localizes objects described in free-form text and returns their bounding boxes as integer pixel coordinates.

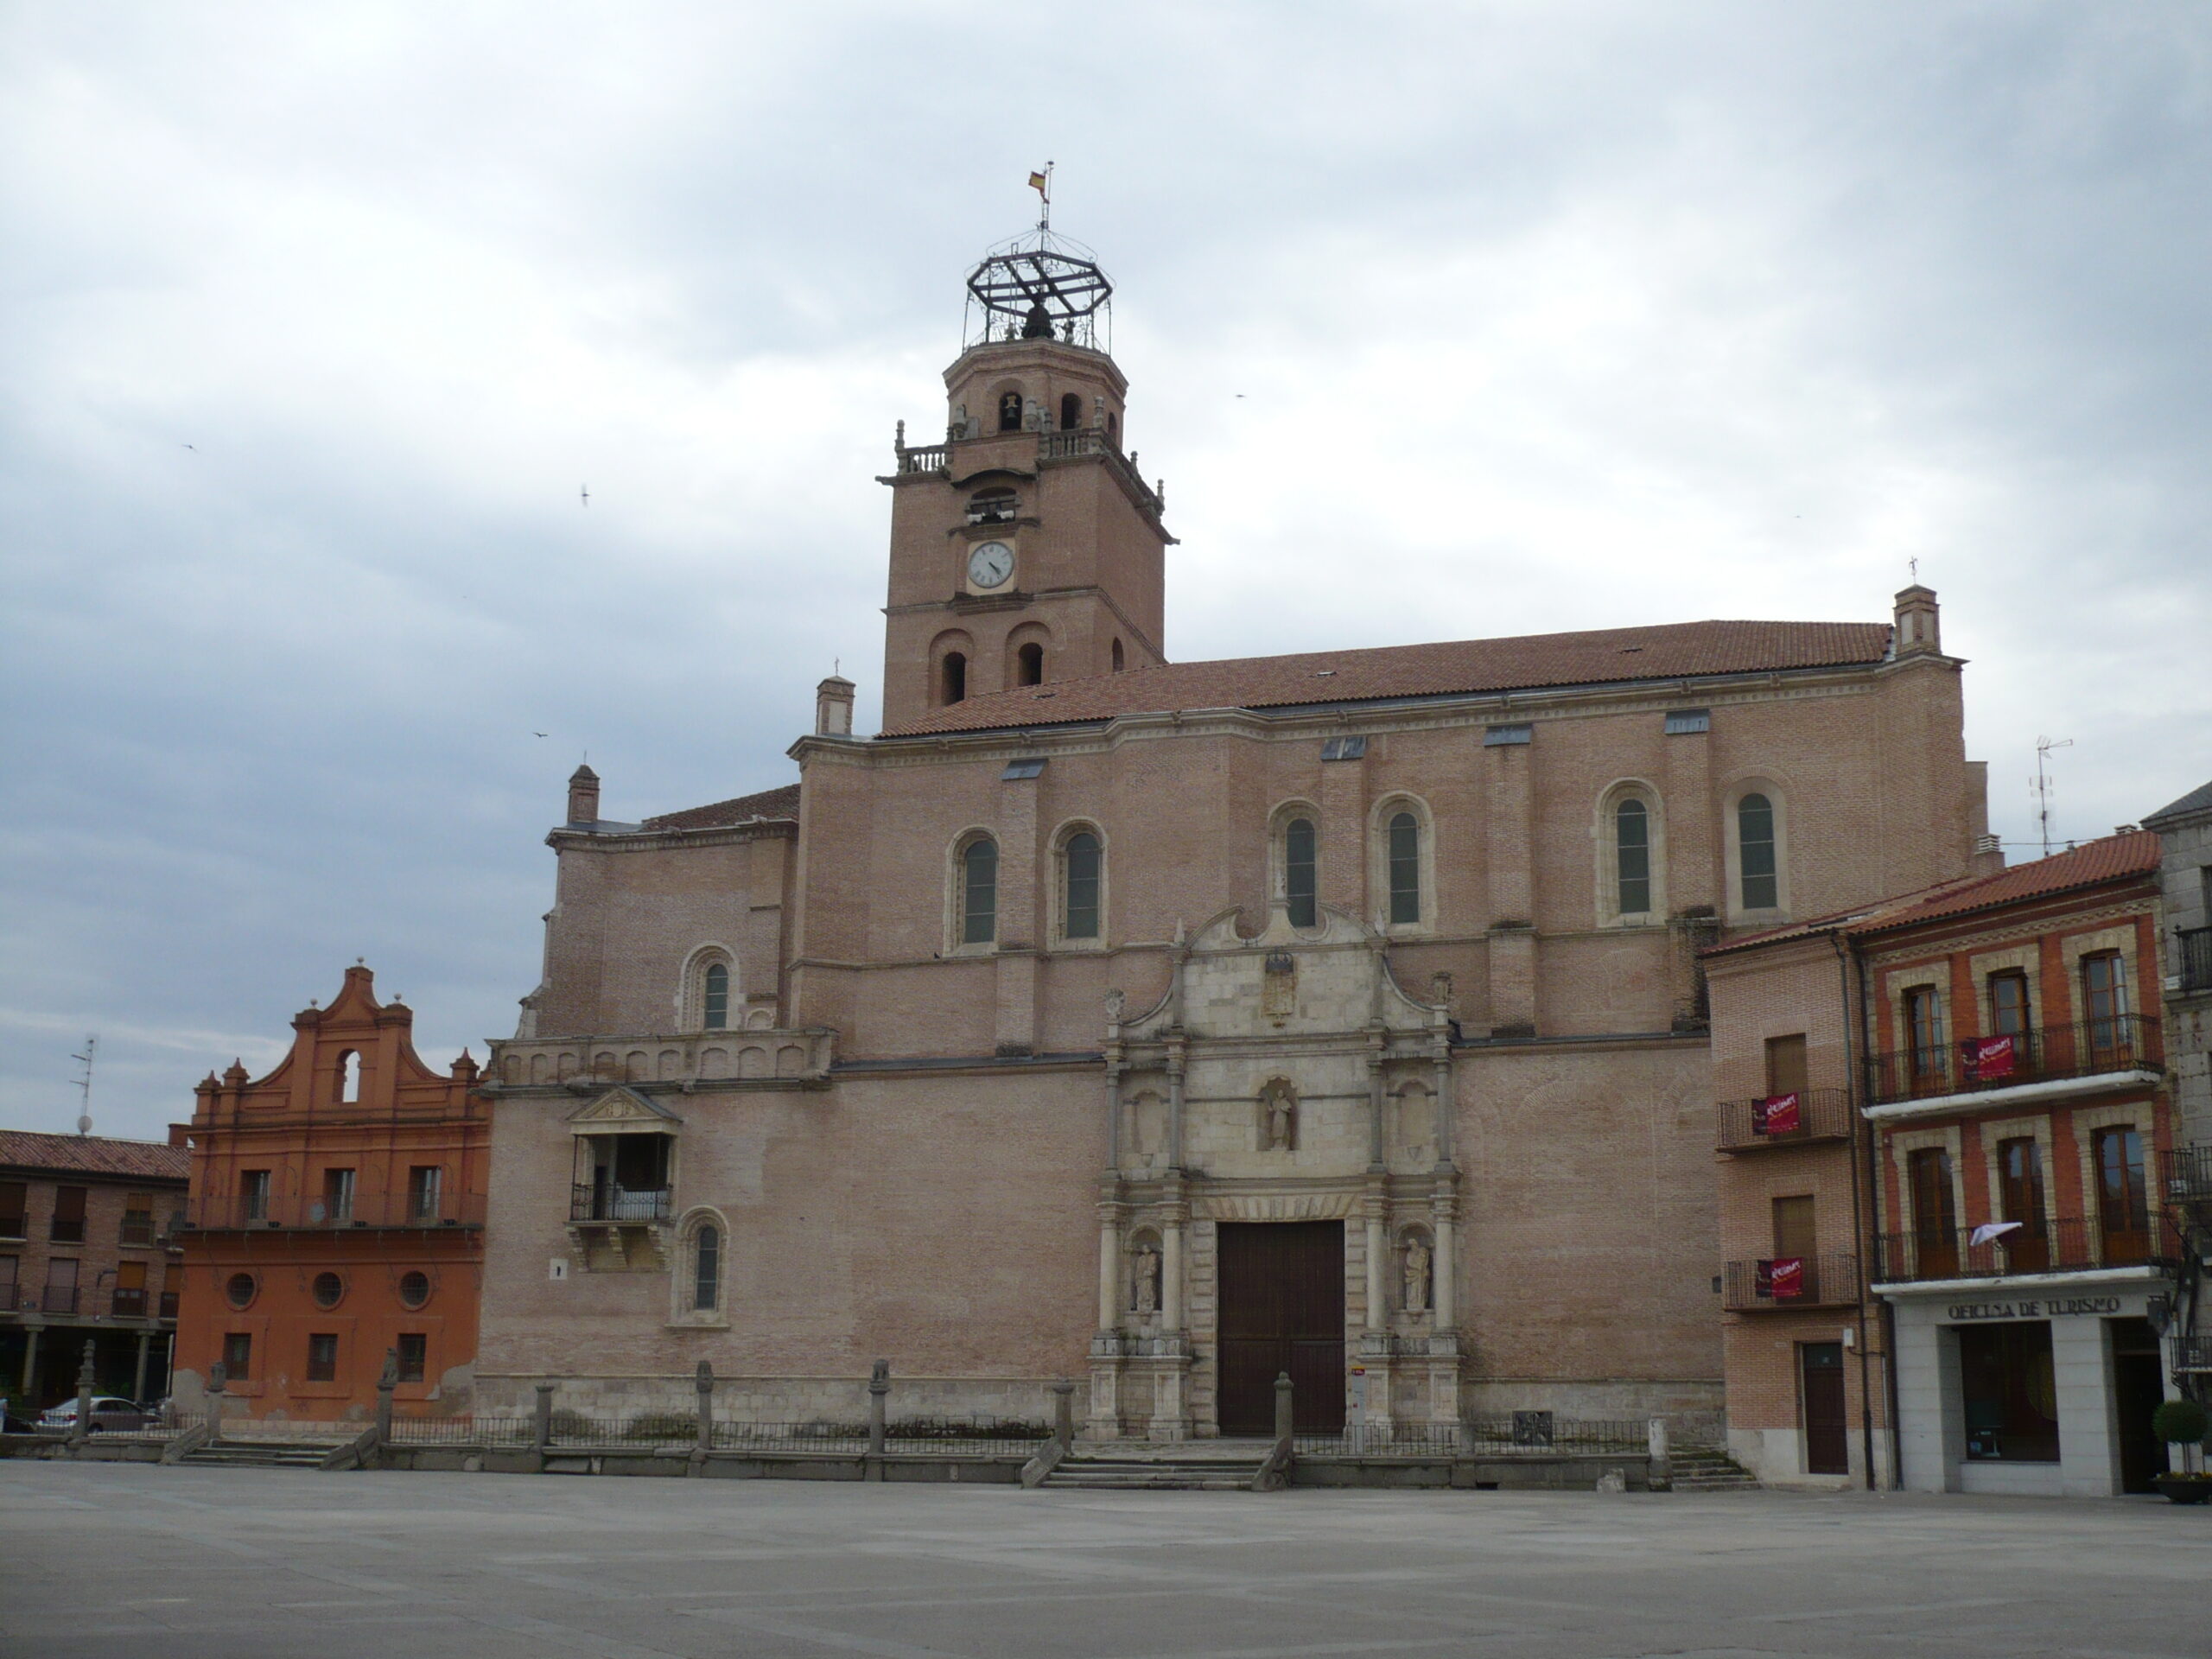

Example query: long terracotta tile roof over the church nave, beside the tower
[882,621,1889,736]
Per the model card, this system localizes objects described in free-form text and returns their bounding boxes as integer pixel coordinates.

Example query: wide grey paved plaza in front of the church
[0,1462,2212,1659]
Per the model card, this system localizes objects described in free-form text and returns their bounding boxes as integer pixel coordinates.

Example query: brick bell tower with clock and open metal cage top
[880,224,1174,730]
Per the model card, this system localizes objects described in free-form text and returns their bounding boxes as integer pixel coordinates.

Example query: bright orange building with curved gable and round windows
[175,967,491,1421]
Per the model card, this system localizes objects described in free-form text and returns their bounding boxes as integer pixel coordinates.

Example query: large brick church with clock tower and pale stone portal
[475,228,1998,1440]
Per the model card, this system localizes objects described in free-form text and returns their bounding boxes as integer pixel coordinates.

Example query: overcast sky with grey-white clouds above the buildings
[0,0,2212,1135]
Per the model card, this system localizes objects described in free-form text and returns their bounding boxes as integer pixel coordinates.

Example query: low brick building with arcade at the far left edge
[0,1130,188,1414]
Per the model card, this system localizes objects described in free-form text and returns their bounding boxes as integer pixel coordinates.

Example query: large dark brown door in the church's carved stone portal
[1214,1221,1344,1435]
